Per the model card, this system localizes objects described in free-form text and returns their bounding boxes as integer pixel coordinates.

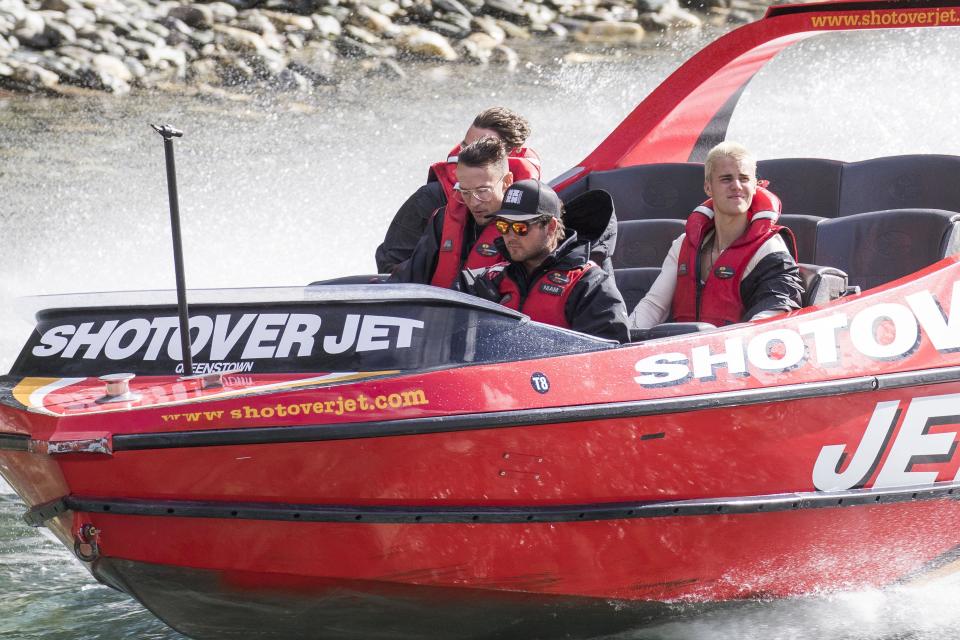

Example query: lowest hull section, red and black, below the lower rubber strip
[71,499,960,638]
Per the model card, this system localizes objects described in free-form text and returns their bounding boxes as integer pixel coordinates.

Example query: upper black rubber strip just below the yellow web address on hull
[113,367,960,451]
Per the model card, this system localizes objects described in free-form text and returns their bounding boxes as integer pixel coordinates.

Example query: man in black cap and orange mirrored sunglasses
[464,180,629,342]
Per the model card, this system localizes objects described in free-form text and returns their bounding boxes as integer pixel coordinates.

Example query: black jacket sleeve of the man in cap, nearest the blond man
[564,266,630,342]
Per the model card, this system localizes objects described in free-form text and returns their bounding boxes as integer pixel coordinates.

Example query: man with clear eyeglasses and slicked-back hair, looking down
[389,137,513,288]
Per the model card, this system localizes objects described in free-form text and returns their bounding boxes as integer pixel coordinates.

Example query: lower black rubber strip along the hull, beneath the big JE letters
[24,482,960,526]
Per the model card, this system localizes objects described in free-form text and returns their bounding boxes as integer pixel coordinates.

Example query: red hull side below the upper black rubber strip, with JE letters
[0,371,960,638]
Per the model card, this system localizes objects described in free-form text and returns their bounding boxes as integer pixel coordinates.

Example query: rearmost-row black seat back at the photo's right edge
[836,155,960,216]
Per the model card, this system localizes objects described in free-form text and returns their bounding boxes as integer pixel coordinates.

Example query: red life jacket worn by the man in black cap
[486,261,599,329]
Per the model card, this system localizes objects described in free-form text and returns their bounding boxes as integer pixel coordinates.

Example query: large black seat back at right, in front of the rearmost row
[814,209,960,289]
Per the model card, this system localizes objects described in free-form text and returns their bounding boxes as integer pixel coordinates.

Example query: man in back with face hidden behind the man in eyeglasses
[376,107,540,273]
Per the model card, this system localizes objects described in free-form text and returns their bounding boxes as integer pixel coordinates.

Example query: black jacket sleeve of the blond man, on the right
[740,251,803,321]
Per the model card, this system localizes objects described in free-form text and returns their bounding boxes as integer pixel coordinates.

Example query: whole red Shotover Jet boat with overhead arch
[0,0,960,638]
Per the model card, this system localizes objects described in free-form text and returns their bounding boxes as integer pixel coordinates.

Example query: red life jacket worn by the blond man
[671,186,796,327]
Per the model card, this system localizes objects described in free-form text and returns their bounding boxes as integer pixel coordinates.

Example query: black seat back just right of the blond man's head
[757,158,844,218]
